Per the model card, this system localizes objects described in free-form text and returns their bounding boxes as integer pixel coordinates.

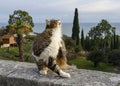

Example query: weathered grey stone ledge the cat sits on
[0,60,120,86]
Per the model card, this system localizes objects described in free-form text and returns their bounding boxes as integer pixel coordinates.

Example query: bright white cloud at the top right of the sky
[79,0,120,12]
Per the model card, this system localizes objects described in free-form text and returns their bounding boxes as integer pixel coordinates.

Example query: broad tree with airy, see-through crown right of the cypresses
[88,19,114,49]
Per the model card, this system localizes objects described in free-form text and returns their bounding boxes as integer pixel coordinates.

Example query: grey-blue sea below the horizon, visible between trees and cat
[0,23,120,36]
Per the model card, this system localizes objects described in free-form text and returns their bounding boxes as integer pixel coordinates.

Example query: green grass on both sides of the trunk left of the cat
[0,43,34,62]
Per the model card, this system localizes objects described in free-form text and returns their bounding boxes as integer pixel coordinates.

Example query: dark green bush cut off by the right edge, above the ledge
[108,50,120,66]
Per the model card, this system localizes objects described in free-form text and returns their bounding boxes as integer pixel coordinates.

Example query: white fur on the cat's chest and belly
[33,28,62,61]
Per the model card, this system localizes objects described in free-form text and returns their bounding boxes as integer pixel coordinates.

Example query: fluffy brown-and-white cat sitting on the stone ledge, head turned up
[32,20,70,78]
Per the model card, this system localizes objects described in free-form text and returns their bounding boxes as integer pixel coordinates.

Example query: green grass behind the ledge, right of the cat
[68,57,114,72]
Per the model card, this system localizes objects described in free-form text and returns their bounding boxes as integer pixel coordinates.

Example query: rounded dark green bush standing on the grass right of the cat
[87,50,105,67]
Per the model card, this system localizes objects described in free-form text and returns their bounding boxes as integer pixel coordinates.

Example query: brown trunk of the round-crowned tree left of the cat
[17,34,23,60]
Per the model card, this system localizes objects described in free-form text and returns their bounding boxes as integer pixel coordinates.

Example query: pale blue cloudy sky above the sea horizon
[0,0,120,23]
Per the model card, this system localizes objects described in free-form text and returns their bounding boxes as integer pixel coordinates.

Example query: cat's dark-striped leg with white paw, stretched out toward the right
[47,57,71,78]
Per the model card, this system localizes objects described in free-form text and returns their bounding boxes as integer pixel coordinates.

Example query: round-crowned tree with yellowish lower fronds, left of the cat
[7,10,34,59]
